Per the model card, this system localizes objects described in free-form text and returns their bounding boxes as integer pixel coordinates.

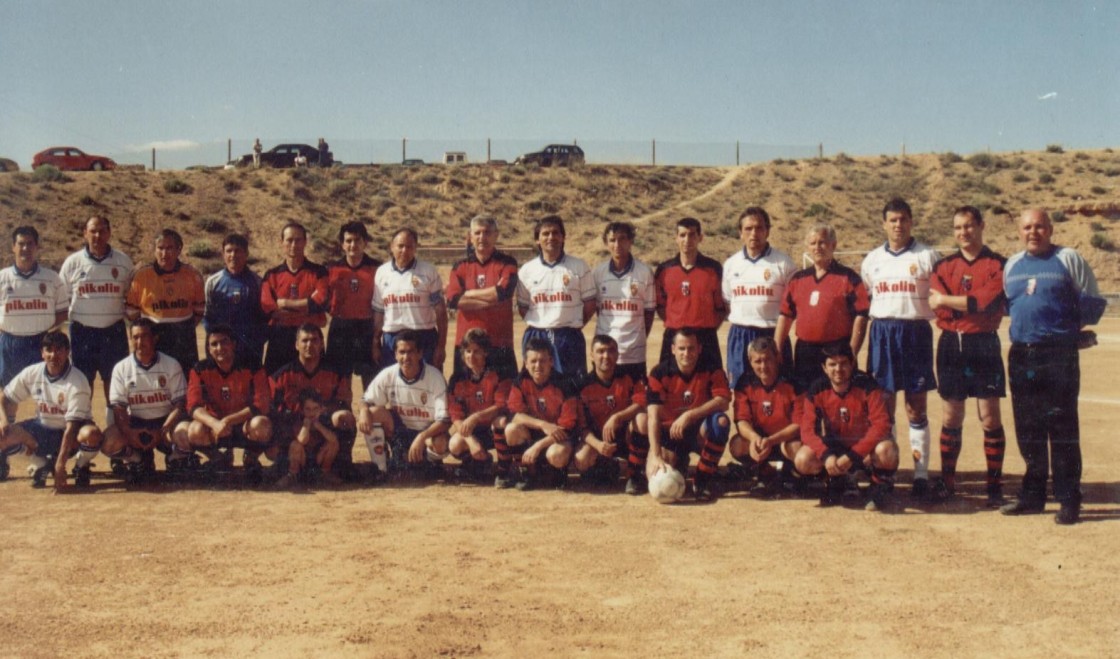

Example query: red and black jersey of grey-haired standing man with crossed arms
[444,250,517,347]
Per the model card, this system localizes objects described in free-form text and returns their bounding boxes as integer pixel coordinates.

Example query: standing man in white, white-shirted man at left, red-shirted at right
[591,222,657,382]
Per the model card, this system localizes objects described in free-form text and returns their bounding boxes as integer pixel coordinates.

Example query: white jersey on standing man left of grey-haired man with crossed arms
[373,259,444,332]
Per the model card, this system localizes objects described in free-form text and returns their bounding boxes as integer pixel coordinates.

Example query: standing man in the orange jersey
[124,229,206,372]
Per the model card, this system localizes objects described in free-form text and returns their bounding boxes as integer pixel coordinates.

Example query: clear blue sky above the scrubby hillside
[0,0,1120,168]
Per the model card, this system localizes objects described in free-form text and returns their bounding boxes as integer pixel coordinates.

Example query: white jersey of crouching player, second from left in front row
[109,352,187,420]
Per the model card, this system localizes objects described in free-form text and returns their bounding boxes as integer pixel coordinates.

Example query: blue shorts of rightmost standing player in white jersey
[867,318,937,393]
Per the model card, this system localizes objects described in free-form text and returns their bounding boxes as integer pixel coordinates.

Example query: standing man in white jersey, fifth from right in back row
[722,206,796,386]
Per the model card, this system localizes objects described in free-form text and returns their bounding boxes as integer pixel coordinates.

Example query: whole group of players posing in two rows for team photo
[0,198,1105,525]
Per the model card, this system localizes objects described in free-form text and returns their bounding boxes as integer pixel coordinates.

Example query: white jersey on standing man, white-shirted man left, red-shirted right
[595,257,657,364]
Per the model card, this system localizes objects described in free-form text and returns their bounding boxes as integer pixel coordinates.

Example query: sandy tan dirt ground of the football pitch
[0,318,1120,657]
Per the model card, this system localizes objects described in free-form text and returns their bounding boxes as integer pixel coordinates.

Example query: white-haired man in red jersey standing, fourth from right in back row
[774,224,870,391]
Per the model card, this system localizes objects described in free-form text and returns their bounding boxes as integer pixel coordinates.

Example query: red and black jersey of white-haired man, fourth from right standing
[782,261,871,343]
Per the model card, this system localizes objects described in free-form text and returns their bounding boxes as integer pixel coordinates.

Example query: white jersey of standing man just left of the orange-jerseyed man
[58,248,132,327]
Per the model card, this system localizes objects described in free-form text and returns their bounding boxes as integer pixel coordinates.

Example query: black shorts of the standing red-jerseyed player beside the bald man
[937,332,1007,400]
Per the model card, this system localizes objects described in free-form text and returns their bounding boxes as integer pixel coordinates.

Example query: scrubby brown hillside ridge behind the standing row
[0,148,1120,291]
